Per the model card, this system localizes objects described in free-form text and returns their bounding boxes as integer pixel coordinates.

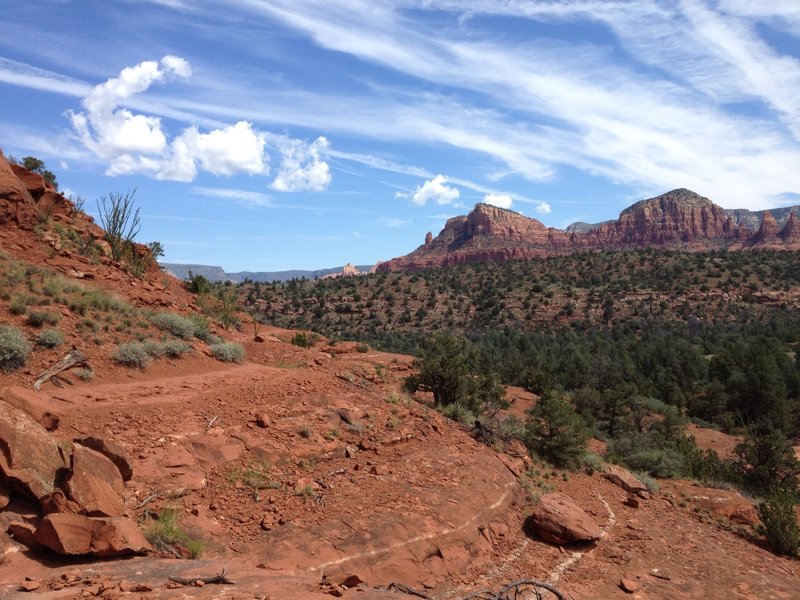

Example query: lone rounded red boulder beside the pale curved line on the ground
[525,492,602,545]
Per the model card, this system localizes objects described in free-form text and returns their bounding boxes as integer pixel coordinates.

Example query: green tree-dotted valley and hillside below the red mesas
[192,249,800,553]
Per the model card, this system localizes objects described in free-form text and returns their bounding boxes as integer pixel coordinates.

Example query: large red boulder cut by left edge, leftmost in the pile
[0,405,66,500]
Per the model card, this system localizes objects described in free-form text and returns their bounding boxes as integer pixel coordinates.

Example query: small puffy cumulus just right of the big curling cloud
[270,136,331,192]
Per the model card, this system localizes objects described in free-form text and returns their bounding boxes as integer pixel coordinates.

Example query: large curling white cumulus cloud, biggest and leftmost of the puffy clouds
[68,55,269,181]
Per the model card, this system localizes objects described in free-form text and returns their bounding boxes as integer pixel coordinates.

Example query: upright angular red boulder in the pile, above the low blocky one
[66,444,125,517]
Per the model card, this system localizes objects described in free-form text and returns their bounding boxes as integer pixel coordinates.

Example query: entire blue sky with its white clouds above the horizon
[0,0,800,271]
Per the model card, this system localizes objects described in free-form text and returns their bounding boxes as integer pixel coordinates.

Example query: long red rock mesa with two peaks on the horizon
[377,188,800,272]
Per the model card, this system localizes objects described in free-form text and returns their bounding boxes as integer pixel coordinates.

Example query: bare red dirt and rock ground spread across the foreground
[0,330,800,599]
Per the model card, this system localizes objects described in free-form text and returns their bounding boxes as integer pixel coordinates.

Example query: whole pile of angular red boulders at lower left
[0,396,150,557]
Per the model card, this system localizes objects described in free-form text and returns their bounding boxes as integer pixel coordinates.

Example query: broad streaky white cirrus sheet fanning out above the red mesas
[222,0,800,207]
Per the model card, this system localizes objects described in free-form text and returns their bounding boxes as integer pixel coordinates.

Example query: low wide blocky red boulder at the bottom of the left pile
[35,514,151,557]
